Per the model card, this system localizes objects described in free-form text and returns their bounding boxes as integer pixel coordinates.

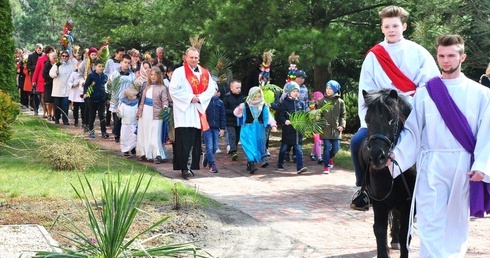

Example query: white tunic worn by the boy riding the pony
[358,38,440,128]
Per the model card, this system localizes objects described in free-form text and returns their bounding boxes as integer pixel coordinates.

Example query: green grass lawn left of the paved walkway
[0,114,207,204]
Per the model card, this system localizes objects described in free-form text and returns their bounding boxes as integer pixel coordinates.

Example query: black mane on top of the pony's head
[364,89,410,122]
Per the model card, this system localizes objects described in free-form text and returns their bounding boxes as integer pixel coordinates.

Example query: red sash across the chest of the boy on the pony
[368,44,417,95]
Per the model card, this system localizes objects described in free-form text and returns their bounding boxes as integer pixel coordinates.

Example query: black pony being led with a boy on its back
[359,89,416,258]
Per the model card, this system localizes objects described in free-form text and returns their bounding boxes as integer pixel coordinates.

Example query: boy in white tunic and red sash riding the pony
[350,5,440,210]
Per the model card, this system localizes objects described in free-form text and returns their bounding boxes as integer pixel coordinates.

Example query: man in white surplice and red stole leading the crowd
[169,47,216,179]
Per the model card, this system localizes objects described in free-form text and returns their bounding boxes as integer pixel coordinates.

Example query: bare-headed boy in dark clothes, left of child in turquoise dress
[223,80,244,161]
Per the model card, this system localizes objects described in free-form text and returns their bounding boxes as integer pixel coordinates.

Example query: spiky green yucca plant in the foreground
[34,174,204,258]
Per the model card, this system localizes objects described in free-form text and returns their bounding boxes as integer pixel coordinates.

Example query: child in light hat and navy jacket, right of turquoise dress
[277,81,308,174]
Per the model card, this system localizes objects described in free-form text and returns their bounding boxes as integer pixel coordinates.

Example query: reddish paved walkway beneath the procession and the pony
[86,131,490,258]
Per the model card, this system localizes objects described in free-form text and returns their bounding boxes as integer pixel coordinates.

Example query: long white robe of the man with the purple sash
[393,74,490,258]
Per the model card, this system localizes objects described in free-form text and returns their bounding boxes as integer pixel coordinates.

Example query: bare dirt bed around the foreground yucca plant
[0,197,301,257]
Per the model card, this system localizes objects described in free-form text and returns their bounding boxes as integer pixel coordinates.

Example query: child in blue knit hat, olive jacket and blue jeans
[316,80,345,174]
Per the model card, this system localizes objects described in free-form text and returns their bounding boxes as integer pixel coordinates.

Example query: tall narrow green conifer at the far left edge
[0,0,18,98]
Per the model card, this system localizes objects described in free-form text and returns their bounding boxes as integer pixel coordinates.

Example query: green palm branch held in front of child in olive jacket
[289,102,332,137]
